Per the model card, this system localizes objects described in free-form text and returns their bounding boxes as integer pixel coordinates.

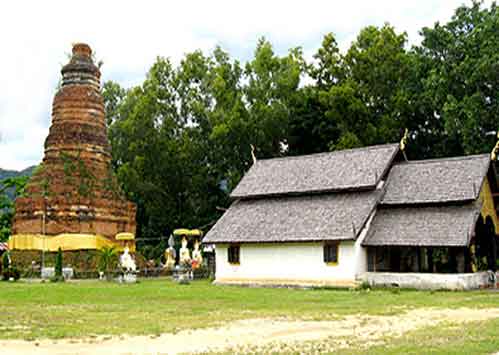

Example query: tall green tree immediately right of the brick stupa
[104,58,184,241]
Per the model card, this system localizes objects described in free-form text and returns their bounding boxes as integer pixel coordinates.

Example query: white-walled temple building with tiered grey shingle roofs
[203,143,499,289]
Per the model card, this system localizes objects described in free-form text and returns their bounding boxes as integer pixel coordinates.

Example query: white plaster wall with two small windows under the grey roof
[216,238,367,285]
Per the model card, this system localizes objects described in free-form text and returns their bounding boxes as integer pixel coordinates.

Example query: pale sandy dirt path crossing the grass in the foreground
[0,308,499,355]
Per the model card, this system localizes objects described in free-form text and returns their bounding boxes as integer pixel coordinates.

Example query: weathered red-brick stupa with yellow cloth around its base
[10,43,136,251]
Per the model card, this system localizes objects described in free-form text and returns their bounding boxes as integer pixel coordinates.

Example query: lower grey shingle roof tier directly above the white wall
[203,190,381,243]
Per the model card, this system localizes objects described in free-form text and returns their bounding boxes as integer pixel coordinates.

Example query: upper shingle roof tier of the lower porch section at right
[382,155,490,205]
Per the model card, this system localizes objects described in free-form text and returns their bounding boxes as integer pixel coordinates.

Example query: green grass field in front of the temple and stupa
[0,279,499,353]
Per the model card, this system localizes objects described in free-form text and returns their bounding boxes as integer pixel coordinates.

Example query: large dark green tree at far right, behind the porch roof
[415,1,499,155]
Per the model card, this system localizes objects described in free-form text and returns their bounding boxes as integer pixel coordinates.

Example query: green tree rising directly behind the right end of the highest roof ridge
[345,24,410,145]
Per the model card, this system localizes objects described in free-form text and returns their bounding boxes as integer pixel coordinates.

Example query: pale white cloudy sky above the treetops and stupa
[0,0,489,170]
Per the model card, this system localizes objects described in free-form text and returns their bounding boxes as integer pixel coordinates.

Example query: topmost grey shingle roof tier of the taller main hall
[231,144,399,198]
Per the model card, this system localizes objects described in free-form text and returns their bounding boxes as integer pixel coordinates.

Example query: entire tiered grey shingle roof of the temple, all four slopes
[203,144,490,246]
